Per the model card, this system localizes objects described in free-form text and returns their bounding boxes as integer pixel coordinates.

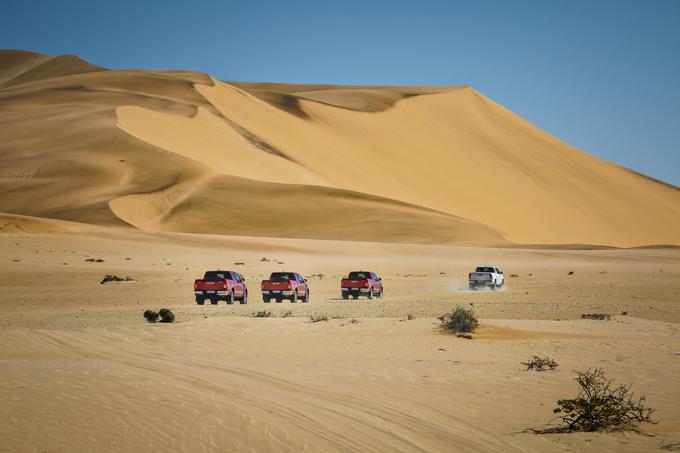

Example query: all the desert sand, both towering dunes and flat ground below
[0,51,680,452]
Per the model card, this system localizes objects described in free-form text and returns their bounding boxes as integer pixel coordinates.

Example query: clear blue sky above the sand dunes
[0,0,680,186]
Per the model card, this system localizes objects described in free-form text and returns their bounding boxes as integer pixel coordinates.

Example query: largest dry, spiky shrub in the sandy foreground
[553,368,654,431]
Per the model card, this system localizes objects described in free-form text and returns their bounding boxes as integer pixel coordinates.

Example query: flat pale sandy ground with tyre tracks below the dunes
[0,229,680,451]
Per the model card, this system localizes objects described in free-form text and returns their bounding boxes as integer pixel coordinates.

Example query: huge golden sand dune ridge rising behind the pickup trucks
[0,51,680,246]
